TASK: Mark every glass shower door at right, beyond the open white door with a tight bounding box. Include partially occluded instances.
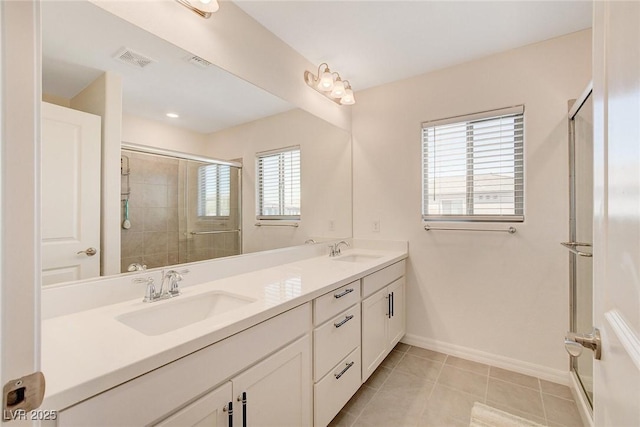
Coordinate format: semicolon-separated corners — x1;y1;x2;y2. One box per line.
570;94;594;407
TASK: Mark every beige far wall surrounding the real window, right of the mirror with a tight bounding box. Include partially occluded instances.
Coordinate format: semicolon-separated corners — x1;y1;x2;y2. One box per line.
353;30;591;380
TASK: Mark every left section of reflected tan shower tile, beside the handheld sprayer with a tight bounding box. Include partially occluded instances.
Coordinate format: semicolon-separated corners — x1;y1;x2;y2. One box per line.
120;150;179;272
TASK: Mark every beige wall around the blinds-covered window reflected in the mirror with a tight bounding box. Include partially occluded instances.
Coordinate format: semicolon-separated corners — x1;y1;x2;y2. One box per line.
208;109;351;252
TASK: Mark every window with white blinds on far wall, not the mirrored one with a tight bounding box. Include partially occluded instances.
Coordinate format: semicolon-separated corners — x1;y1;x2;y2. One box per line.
422;106;524;221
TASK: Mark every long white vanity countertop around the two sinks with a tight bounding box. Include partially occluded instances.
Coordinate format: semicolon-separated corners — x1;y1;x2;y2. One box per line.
42;248;407;410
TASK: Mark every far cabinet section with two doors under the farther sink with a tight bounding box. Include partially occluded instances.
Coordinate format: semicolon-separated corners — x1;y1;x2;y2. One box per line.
362;261;406;382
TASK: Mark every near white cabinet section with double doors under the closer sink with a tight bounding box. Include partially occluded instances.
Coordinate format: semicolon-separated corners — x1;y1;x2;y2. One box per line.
58;303;313;427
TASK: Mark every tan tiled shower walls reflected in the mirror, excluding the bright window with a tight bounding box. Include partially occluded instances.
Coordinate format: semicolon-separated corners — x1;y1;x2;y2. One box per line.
120;150;242;272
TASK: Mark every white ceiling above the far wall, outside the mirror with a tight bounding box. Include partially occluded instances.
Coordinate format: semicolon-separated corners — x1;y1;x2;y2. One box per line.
234;0;592;91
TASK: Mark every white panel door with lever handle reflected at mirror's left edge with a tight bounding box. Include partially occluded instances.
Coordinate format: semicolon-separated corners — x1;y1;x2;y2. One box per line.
42;102;101;285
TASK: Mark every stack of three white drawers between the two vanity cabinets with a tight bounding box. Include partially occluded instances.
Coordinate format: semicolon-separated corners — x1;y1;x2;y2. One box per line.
313;280;362;426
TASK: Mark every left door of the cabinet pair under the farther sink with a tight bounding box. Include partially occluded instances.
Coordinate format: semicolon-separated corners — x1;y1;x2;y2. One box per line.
362;288;389;382
